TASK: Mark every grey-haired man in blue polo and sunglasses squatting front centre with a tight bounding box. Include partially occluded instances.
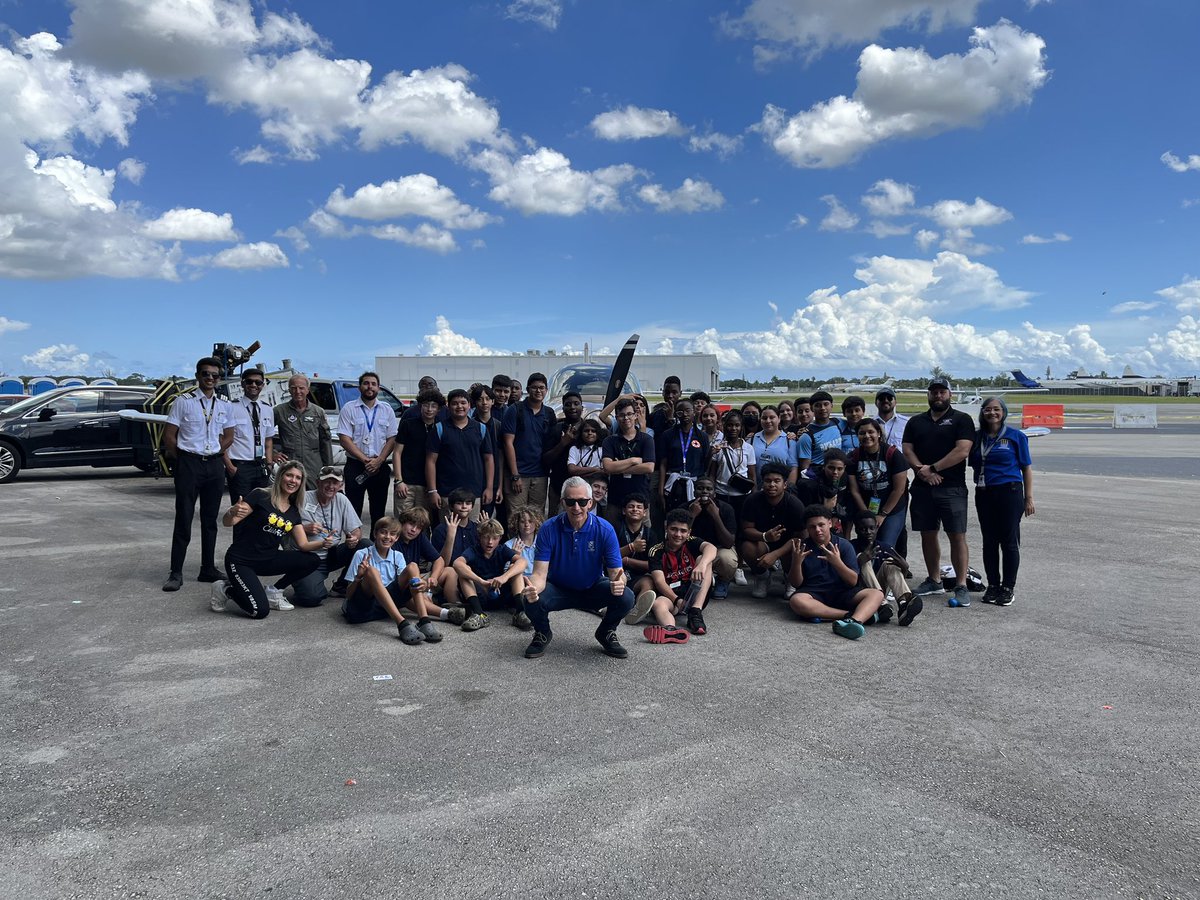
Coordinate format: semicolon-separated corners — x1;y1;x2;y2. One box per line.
524;475;634;659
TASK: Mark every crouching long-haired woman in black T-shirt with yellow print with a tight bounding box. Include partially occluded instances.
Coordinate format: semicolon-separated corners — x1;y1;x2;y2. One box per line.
211;460;335;619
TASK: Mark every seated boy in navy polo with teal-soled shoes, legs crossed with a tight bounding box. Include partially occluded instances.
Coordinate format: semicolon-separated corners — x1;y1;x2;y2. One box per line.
788;504;883;641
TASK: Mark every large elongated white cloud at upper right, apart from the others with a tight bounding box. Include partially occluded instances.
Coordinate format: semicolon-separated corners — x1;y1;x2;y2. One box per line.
756;20;1049;168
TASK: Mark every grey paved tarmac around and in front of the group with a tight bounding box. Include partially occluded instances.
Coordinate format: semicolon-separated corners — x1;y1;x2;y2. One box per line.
0;430;1200;900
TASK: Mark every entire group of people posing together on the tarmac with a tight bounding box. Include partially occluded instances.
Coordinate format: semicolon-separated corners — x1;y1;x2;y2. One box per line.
163;358;1034;658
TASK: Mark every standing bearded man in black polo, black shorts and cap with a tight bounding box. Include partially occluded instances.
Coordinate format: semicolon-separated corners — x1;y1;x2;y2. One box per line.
904;378;974;606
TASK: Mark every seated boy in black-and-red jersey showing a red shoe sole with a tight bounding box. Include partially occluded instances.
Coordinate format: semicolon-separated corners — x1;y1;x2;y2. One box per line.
625;509;716;643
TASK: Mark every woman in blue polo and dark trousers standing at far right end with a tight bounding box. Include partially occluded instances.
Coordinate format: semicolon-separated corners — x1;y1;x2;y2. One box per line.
967;397;1033;606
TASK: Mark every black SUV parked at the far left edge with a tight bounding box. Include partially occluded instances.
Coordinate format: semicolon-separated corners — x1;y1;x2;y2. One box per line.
0;385;154;485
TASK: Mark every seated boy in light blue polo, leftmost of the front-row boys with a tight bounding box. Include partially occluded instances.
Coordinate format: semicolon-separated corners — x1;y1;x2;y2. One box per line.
342;516;442;644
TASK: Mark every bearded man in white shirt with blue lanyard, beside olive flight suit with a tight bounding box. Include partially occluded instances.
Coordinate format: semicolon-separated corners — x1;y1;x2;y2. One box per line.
337;372;398;532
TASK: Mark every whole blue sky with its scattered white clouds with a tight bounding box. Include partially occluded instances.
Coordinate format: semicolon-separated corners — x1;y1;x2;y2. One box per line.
0;0;1200;377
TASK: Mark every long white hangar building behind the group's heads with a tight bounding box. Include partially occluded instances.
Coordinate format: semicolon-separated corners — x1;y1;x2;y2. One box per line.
376;350;721;397
